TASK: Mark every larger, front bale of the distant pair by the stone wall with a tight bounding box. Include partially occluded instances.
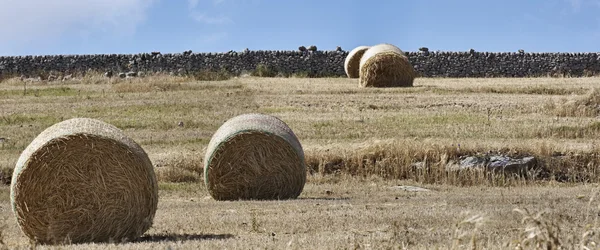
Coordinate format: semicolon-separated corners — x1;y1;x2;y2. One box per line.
359;44;417;87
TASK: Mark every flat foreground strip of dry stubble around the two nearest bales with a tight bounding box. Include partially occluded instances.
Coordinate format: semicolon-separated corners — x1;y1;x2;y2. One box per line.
2;178;600;249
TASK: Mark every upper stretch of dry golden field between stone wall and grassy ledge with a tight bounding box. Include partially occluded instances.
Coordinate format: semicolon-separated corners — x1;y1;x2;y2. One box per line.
0;77;600;182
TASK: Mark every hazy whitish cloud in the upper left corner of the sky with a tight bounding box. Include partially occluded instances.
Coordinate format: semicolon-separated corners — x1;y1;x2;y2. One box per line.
0;0;158;54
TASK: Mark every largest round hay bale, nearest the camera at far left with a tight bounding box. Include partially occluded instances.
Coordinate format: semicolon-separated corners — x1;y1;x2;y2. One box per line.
10;118;158;244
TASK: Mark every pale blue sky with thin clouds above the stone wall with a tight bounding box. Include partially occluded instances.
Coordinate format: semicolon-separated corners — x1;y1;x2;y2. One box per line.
0;0;600;56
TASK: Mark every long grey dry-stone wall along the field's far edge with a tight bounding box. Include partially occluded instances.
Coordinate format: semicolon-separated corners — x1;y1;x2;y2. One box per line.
0;51;600;79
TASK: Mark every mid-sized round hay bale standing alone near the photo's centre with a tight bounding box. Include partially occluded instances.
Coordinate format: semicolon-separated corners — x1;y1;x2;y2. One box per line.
204;114;306;200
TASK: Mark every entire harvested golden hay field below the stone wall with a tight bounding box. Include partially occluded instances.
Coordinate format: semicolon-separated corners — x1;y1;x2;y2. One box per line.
0;77;600;249
